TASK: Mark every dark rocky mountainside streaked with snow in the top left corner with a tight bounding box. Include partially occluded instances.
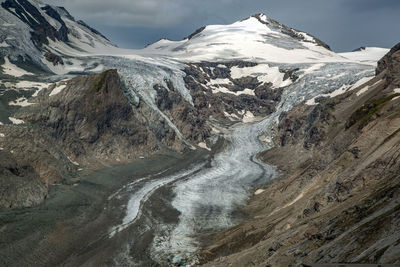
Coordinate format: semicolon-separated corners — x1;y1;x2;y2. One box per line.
0;0;113;73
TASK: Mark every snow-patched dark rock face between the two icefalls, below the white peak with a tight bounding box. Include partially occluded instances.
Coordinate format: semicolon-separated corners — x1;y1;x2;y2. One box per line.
184;61;289;122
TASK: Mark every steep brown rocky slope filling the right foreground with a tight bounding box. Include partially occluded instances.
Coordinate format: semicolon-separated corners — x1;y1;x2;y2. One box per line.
203;45;400;266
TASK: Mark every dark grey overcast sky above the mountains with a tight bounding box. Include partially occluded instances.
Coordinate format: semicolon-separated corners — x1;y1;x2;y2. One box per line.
43;0;400;51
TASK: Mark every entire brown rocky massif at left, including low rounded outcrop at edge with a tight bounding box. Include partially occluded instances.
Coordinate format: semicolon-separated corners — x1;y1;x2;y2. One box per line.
0;70;185;208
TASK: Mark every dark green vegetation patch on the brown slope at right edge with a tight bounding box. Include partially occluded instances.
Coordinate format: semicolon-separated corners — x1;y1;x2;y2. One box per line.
346;93;400;130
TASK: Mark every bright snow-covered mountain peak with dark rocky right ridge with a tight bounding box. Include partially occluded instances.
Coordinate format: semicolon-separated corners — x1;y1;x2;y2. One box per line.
144;14;343;63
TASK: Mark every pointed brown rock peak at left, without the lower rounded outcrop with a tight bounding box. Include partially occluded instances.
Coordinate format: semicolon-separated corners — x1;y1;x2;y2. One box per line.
21;70;161;163
